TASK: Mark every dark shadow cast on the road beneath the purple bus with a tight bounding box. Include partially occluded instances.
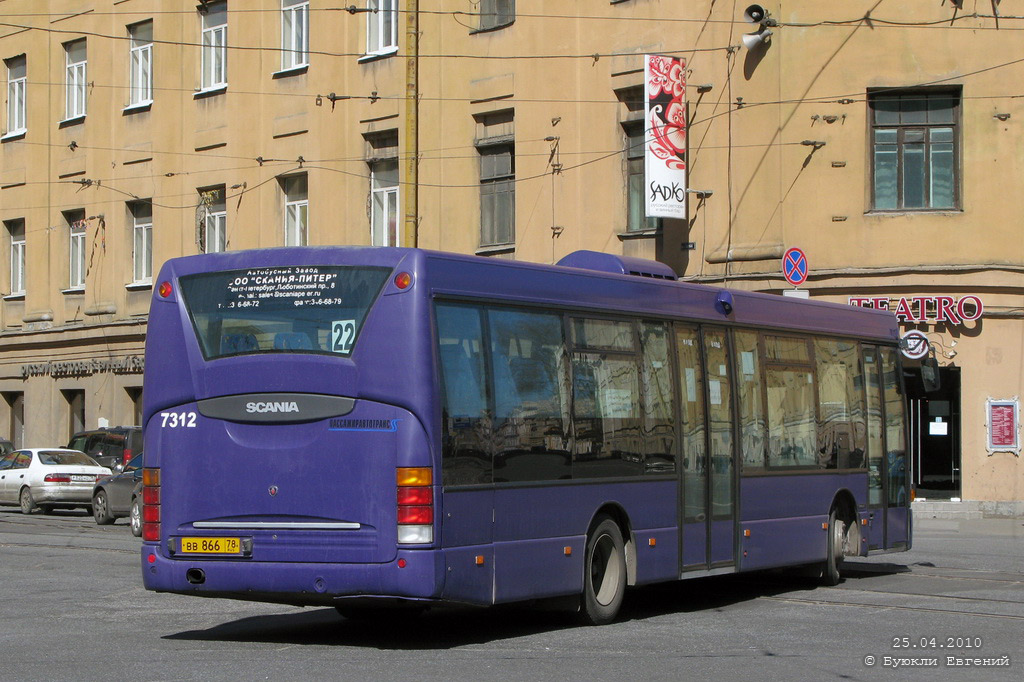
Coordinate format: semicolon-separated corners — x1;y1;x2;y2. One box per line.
164;563;909;650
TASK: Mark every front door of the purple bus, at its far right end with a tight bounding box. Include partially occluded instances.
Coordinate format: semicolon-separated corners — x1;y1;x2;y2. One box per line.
864;345;910;549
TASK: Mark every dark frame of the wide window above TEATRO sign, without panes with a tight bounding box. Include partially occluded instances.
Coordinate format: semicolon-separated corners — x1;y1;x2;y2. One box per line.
867;88;963;213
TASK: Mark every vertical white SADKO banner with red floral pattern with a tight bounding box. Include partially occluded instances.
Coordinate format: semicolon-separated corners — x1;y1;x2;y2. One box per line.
644;54;686;218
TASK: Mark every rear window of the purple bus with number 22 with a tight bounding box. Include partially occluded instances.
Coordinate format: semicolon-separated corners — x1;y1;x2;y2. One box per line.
179;265;390;359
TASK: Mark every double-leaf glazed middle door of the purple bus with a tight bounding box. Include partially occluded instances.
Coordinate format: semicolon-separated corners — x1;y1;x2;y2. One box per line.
676;326;734;570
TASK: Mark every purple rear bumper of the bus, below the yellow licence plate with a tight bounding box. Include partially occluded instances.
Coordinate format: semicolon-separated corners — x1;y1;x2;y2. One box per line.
141;544;444;606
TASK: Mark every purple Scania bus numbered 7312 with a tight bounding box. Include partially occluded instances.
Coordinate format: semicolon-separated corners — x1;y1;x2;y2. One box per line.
141;247;911;624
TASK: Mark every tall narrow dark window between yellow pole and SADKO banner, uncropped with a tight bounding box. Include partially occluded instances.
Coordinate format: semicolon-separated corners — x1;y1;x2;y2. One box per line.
476;112;515;247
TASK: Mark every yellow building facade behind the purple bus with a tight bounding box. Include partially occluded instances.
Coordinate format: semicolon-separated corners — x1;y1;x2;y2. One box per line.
0;0;1024;504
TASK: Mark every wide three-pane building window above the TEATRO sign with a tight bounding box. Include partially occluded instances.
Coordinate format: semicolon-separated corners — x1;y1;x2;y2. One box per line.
868;90;961;211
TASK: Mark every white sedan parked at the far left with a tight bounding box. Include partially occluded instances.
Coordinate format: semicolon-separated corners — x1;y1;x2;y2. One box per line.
0;447;111;514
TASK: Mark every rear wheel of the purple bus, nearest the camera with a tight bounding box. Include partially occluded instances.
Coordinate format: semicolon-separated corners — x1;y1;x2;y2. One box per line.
581;516;626;625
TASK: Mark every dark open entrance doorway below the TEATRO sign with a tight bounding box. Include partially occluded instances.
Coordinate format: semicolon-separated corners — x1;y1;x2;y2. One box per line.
905;367;961;499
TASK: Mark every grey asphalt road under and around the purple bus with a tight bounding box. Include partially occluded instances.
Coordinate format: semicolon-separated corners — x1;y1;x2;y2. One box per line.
0;507;1024;682
